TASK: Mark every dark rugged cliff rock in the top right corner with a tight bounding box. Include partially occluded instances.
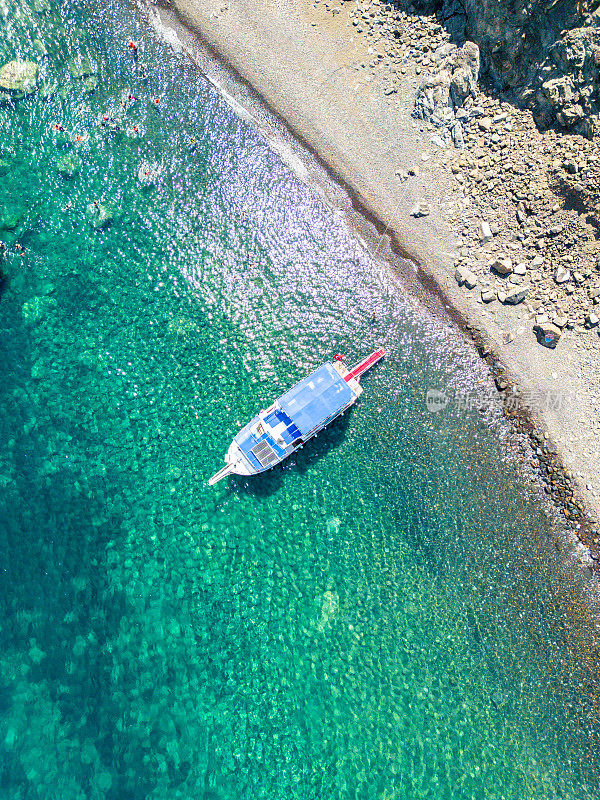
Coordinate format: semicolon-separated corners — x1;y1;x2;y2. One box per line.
413;0;600;137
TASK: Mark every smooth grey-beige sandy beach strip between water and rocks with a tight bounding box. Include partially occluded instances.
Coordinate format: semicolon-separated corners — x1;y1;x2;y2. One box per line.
144;0;600;544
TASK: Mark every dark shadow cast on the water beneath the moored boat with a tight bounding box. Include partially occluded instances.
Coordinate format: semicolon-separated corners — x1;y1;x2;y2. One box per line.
230;408;354;497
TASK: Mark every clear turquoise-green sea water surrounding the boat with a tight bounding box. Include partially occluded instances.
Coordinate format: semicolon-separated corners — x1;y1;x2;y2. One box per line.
0;4;598;800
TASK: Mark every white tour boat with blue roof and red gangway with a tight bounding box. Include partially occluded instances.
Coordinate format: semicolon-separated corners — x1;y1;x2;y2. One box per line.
208;348;385;486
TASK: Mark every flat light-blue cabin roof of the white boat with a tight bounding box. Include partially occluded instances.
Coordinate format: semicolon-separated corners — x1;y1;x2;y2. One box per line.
277;361;354;436
